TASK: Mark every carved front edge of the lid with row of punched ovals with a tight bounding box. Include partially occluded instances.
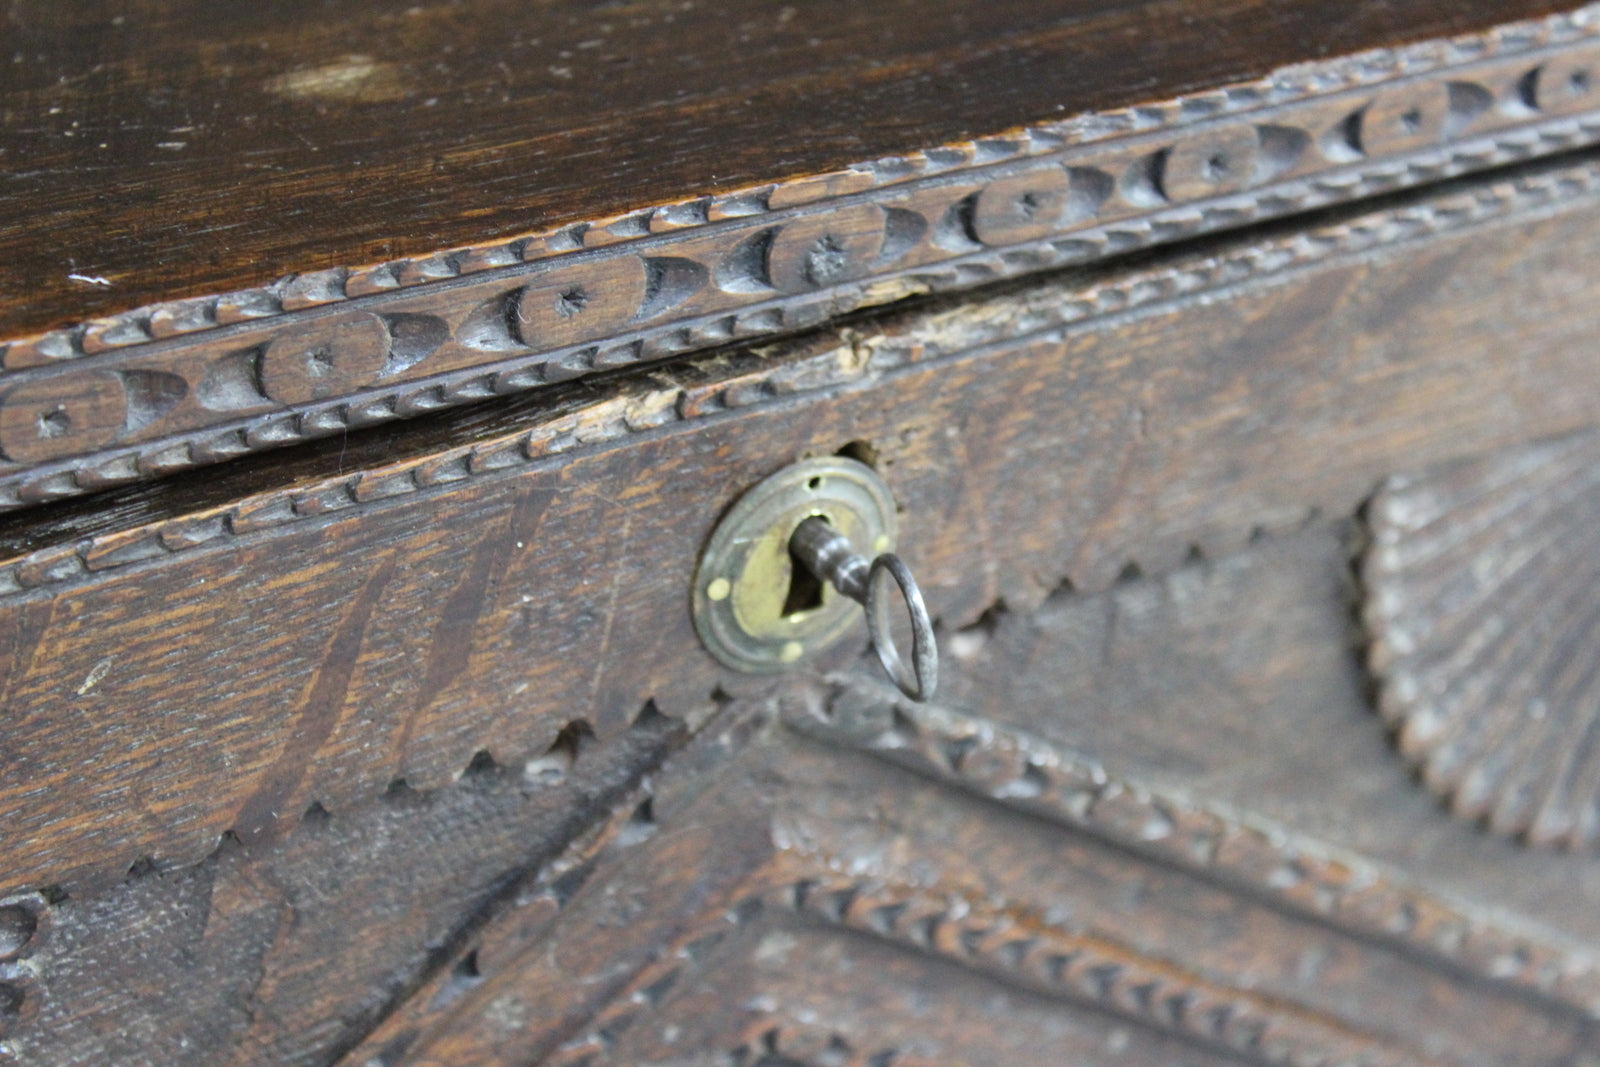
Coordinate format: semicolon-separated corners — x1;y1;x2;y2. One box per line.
9;6;1600;509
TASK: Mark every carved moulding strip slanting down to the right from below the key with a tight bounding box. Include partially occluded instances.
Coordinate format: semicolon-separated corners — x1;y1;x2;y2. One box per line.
786;683;1600;1017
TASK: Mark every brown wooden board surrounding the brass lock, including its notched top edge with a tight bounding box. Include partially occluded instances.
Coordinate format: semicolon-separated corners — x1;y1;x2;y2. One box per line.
0;146;1600;889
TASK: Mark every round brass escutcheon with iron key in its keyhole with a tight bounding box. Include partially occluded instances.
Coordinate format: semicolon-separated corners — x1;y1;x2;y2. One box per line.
693;456;938;699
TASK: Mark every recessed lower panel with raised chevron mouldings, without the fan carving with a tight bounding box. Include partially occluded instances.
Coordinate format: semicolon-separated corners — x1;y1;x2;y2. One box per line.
18;523;1600;1067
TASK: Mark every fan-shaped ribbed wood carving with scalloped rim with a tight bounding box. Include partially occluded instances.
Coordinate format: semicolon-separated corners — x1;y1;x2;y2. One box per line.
1365;434;1600;848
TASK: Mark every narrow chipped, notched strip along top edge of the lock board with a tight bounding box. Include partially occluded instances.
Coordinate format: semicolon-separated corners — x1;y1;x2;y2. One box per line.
0;147;1600;603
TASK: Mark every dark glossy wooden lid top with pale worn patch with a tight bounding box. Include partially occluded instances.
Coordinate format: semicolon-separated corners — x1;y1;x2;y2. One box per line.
0;0;1573;336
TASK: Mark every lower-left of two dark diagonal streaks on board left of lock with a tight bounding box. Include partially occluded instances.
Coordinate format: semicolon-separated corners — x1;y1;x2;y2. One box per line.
234;557;397;845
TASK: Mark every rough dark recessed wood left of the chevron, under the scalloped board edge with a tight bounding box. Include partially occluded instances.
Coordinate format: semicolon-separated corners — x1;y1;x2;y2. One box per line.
0;712;683;1067
